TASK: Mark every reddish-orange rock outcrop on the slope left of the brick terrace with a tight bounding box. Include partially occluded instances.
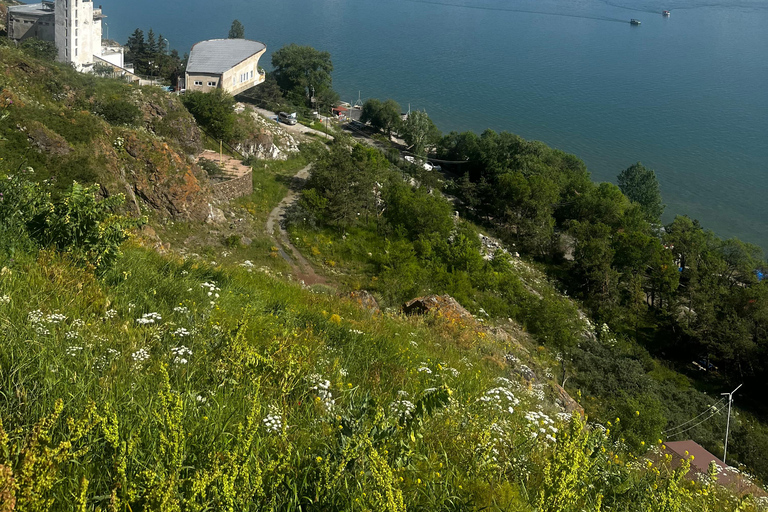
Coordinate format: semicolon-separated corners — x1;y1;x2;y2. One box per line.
123;134;211;220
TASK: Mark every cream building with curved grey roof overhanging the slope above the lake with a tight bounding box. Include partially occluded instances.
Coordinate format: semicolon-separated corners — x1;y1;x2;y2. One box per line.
185;39;267;95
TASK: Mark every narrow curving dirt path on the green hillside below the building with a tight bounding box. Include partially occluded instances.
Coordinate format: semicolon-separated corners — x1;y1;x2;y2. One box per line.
265;164;328;286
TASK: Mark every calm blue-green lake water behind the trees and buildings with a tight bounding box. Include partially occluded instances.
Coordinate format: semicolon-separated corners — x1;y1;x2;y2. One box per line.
99;0;768;248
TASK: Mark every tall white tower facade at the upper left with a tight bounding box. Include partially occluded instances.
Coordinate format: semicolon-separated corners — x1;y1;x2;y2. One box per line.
55;0;103;71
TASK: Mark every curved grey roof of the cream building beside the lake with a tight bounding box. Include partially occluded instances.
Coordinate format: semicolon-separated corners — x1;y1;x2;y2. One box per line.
187;39;267;75
